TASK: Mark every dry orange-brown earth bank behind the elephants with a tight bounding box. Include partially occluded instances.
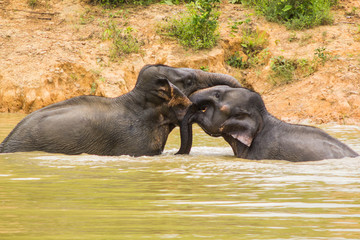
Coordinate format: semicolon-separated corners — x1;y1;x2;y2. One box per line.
0;0;360;124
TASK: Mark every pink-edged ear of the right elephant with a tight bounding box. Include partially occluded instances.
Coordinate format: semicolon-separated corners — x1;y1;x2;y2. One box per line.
220;113;258;147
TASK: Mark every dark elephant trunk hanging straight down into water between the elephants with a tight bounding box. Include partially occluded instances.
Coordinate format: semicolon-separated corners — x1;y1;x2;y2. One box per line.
176;105;197;154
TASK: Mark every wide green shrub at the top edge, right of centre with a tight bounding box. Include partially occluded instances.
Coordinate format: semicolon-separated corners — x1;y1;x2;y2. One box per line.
232;0;337;29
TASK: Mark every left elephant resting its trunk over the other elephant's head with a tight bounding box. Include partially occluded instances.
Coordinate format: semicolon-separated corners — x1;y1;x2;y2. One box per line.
0;65;240;156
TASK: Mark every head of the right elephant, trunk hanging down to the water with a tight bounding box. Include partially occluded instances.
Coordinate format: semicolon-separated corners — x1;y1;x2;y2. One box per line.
179;86;266;156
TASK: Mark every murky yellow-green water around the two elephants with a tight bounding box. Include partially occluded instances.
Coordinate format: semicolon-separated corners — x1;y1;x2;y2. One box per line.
0;114;360;240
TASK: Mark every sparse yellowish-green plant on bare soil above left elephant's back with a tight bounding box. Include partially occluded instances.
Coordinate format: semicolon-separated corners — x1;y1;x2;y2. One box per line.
102;21;142;60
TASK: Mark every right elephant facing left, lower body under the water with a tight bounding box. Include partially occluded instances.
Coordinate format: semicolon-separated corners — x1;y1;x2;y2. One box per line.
182;86;359;162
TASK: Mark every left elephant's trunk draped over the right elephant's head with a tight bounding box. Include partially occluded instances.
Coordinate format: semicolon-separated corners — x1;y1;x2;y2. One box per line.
196;70;241;88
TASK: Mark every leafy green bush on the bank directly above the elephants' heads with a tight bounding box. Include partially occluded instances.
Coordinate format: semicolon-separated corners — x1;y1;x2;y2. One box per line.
158;0;220;50
